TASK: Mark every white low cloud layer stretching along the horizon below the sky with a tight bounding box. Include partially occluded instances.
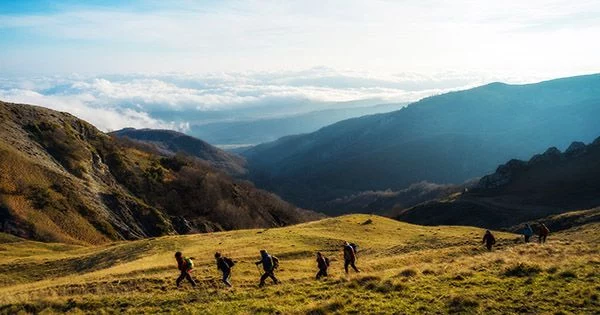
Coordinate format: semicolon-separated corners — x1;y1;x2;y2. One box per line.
0;68;560;131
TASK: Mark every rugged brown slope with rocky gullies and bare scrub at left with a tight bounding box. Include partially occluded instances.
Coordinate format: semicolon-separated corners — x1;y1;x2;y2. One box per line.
0;102;315;244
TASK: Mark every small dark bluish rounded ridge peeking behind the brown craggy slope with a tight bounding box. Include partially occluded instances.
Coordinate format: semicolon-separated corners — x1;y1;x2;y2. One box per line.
111;128;247;176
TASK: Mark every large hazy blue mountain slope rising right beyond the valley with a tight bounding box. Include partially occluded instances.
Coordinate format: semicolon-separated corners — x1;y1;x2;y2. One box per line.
244;75;600;209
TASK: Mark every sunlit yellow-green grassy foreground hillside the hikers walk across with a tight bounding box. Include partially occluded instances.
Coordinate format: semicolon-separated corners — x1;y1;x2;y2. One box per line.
0;215;600;314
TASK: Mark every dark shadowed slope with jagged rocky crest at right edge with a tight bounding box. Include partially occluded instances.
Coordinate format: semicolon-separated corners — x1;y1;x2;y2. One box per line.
396;137;600;228
